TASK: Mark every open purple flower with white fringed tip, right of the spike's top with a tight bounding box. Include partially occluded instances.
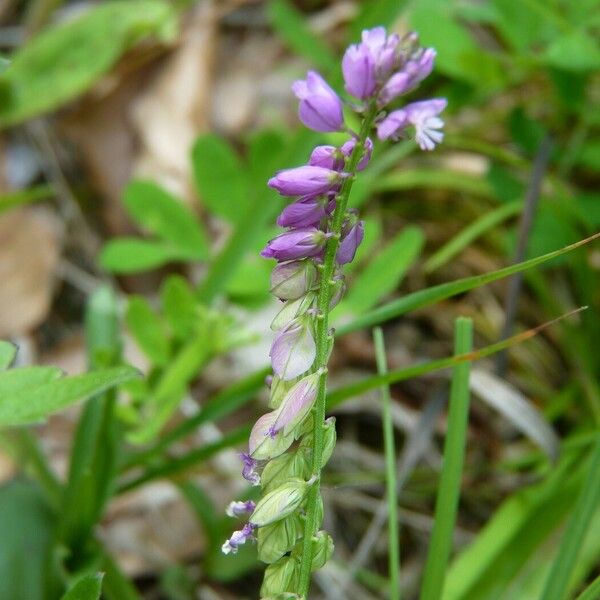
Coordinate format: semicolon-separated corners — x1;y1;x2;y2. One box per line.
377;98;447;150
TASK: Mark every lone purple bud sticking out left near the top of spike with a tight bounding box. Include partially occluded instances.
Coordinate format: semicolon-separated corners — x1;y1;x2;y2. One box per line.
292;71;344;132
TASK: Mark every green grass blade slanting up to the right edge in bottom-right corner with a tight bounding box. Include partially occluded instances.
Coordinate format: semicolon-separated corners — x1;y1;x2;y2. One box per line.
540;435;600;600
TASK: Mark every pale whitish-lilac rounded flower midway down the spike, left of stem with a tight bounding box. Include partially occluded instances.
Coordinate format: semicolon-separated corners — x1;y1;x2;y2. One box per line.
269;317;317;380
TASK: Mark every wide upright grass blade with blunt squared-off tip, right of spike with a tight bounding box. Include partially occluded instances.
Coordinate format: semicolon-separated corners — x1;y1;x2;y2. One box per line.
420;317;473;600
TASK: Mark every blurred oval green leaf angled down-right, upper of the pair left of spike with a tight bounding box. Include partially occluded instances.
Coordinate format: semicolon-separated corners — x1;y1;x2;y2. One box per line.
123;180;208;260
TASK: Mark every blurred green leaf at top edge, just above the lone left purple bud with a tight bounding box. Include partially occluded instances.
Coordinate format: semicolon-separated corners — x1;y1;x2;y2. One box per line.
268;0;338;73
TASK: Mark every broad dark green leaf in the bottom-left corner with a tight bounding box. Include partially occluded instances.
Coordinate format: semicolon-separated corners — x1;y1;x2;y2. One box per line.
0;480;64;600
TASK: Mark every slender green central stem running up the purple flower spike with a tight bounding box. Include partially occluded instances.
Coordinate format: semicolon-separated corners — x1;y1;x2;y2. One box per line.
299;103;377;597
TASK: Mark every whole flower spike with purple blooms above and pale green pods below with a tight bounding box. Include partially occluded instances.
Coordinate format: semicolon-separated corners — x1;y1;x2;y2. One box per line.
223;27;446;598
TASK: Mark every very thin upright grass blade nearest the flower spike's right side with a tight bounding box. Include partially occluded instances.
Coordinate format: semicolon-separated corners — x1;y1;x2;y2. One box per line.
373;327;400;600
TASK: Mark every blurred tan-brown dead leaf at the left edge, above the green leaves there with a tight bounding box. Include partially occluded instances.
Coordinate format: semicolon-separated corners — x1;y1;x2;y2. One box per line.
0;208;61;337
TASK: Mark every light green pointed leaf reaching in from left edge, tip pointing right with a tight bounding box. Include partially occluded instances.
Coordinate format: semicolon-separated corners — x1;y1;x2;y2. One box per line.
0;367;139;426
